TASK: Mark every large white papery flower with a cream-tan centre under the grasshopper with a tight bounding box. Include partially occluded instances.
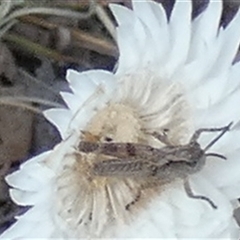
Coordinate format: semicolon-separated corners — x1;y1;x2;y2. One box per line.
1;0;240;239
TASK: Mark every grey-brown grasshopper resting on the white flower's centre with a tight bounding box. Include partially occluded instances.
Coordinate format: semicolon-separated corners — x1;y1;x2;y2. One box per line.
79;122;232;209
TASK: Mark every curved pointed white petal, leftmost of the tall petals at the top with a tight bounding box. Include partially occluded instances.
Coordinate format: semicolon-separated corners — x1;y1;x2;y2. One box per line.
110;4;152;74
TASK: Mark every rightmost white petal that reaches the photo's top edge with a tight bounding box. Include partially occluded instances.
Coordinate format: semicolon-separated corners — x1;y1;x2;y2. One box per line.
175;0;223;86
